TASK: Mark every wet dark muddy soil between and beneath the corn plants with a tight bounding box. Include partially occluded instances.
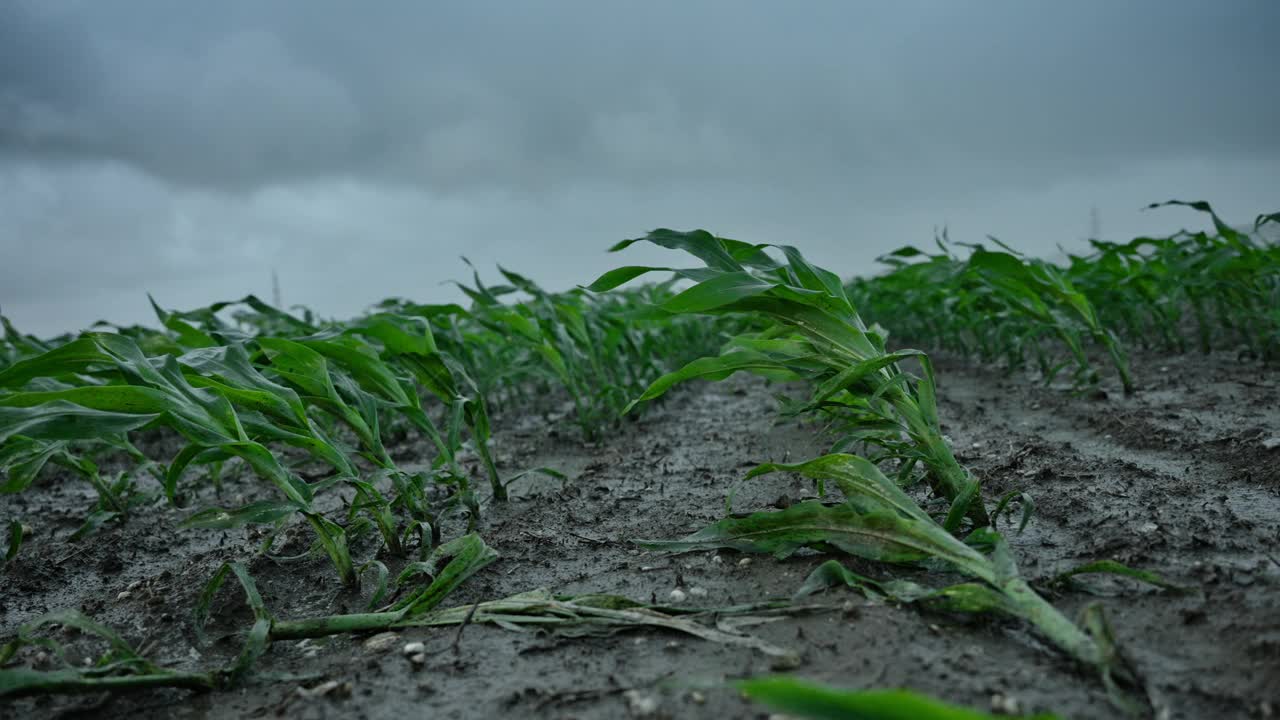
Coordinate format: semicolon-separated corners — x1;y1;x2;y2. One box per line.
0;345;1280;720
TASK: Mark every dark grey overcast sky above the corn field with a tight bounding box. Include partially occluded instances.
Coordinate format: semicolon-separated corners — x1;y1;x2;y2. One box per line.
0;0;1280;334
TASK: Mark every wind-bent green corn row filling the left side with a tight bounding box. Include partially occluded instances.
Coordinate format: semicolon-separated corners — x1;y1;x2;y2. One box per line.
0;270;718;585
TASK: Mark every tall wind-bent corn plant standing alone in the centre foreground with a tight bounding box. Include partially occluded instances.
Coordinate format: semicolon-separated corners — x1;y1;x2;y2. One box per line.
589;229;987;529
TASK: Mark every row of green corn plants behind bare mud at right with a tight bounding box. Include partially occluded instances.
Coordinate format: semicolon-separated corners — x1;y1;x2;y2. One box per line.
847;200;1280;392
